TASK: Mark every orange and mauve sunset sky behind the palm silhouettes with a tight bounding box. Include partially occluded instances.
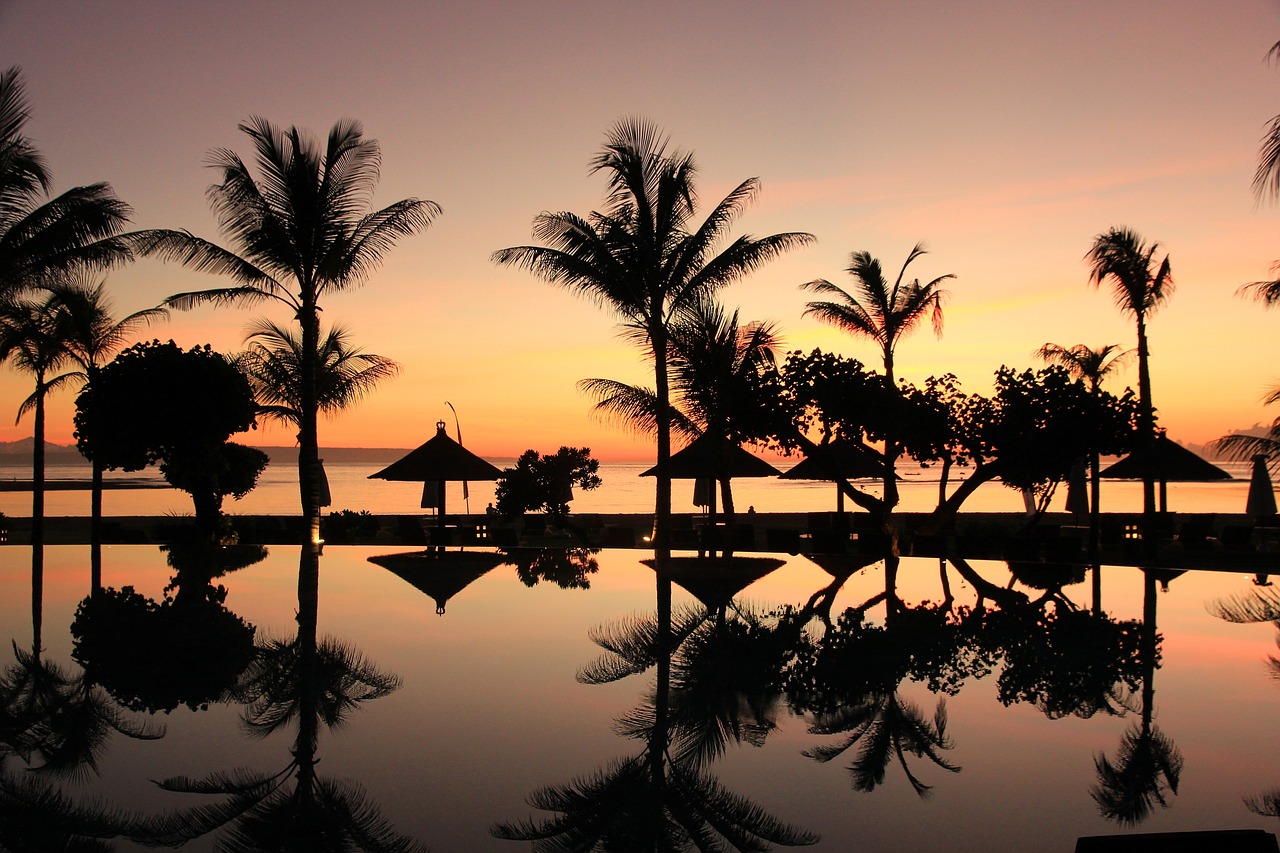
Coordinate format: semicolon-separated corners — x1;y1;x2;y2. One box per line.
0;0;1280;459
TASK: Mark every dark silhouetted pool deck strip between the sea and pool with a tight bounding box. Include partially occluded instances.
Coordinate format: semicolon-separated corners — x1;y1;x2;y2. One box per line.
5;512;1280;574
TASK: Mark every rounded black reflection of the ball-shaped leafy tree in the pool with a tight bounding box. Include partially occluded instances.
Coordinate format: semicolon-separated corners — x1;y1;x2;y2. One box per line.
72;578;255;712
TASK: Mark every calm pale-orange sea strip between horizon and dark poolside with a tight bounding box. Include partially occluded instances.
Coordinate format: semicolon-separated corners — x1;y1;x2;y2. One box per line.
0;456;1249;517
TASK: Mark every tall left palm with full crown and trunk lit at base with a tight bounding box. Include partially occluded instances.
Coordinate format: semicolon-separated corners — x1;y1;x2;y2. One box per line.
134;117;440;542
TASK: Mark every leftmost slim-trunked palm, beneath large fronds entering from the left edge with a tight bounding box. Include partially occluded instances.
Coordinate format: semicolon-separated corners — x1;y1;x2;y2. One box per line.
0;293;77;546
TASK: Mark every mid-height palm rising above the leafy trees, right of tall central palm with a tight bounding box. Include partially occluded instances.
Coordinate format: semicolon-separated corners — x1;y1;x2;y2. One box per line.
800;243;955;515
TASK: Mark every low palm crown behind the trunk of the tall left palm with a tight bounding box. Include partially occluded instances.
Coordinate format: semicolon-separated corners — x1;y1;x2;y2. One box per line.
234;319;399;427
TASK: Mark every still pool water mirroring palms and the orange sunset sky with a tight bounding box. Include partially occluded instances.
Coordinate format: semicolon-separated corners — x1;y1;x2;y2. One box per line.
0;546;1280;850
